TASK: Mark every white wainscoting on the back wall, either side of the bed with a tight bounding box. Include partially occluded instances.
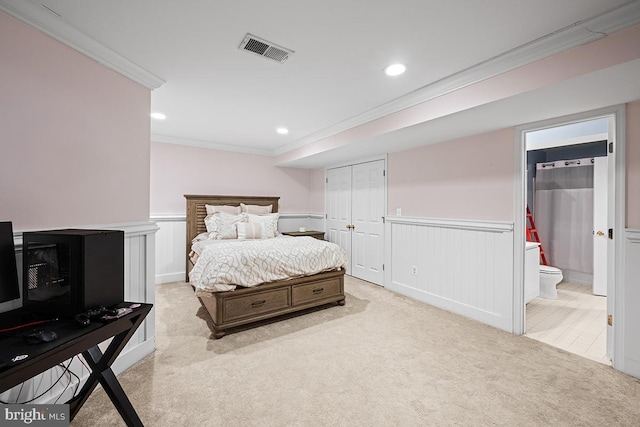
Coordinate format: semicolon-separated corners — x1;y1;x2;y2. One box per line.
151;212;324;284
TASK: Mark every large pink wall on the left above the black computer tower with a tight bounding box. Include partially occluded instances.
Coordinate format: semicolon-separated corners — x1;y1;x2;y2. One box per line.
0;12;150;230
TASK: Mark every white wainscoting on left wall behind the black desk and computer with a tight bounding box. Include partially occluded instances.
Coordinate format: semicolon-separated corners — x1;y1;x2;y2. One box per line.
0;222;158;403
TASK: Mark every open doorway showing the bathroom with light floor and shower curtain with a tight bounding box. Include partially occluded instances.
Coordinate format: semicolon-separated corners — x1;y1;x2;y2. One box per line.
525;123;611;365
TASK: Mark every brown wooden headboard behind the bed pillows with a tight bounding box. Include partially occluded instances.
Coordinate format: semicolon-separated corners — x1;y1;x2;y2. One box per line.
184;194;280;282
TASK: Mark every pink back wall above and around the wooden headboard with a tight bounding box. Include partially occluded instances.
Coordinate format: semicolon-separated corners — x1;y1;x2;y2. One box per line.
151;142;324;215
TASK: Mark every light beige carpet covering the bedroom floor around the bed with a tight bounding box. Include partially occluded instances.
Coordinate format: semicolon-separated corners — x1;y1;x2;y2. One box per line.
72;277;640;427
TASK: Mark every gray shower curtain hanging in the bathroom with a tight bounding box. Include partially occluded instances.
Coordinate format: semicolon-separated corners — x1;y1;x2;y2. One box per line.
534;159;593;285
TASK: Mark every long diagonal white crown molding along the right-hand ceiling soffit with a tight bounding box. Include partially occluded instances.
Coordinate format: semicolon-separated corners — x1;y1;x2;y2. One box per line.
274;0;640;155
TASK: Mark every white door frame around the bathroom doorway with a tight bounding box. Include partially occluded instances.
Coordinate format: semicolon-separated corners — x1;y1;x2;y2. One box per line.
512;104;627;370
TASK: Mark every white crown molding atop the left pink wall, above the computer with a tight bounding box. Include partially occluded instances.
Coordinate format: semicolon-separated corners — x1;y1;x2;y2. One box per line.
0;0;165;90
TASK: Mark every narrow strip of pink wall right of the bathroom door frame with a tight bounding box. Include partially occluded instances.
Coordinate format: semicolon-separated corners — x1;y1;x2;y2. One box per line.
626;101;640;229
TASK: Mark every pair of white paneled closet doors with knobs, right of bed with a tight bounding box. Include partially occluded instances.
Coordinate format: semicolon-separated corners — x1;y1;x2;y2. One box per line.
326;160;385;285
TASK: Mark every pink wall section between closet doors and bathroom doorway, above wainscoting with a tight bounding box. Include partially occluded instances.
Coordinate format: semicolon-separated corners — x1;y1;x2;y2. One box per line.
387;128;515;221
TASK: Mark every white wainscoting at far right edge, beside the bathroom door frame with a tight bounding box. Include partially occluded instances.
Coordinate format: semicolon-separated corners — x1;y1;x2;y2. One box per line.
614;229;640;378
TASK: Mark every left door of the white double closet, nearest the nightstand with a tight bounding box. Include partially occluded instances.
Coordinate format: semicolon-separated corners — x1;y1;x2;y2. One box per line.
326;166;352;274
